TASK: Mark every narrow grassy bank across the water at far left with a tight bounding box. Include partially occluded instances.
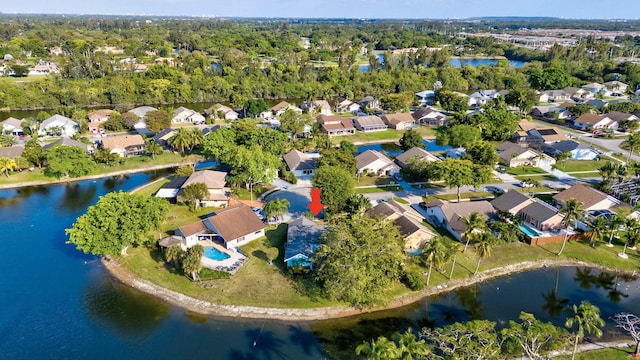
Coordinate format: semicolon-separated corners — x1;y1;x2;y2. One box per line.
0;153;201;185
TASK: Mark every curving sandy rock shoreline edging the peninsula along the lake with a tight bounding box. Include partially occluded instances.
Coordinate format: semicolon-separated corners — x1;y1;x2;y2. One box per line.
101;258;631;321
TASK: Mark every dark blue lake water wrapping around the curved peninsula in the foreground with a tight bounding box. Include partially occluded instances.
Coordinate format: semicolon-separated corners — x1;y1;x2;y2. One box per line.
0;172;640;360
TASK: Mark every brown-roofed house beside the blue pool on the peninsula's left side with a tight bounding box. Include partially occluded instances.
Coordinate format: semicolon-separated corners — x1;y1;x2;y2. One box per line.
205;204;265;249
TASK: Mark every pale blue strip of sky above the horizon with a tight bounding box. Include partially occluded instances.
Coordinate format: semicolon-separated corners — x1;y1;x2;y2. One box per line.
0;0;640;19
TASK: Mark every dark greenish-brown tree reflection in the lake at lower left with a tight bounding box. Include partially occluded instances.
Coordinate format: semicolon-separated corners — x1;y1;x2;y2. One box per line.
85;275;170;336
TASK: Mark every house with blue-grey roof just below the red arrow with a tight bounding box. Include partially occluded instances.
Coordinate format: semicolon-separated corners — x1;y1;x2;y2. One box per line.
284;216;327;268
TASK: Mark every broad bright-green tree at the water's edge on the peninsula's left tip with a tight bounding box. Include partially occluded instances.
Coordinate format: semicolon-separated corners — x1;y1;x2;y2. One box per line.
66;192;169;256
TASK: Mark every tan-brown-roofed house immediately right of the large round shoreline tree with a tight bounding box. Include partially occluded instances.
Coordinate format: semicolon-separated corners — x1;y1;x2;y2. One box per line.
367;201;436;250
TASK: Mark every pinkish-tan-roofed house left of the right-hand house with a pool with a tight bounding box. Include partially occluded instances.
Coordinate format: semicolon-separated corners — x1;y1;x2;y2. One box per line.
425;200;498;240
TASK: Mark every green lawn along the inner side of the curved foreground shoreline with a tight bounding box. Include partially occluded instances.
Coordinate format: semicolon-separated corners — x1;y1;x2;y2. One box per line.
121;181;640;308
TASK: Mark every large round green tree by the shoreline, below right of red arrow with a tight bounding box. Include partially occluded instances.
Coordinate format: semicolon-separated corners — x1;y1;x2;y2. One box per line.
313;215;404;306
